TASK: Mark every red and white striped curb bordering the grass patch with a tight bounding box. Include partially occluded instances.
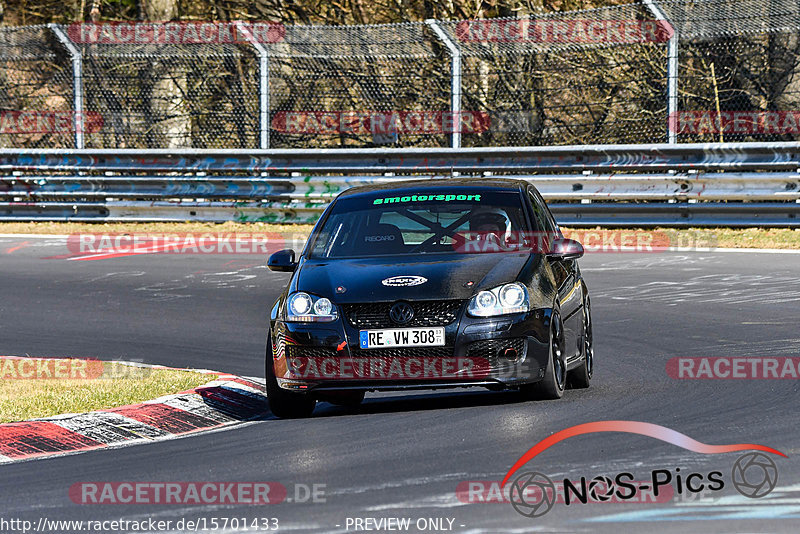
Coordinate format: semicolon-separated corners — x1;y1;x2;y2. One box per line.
0;362;267;464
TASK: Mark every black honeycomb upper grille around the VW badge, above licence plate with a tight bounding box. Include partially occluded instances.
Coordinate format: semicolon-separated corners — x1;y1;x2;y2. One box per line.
342;300;464;328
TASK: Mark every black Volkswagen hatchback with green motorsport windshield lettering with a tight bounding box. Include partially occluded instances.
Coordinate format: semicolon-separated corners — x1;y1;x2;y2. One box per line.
266;179;593;417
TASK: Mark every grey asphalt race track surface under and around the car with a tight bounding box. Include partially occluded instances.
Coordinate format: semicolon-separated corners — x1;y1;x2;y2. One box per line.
0;237;800;532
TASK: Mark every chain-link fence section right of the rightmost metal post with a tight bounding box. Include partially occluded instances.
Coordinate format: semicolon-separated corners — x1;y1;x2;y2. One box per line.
659;0;800;142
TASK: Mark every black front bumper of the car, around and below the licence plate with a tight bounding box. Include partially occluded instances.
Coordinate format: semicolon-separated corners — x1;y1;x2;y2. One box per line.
271;309;552;392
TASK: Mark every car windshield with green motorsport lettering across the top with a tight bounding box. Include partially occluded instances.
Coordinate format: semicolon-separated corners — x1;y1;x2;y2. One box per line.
310;188;530;258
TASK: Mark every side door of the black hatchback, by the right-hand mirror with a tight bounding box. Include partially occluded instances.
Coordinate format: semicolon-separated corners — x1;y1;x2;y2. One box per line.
528;186;583;361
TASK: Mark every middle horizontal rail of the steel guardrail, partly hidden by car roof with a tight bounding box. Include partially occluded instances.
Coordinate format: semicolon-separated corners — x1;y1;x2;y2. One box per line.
0;172;800;201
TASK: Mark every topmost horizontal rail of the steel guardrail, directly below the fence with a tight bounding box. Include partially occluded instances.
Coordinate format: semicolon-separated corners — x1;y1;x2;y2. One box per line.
0;142;800;173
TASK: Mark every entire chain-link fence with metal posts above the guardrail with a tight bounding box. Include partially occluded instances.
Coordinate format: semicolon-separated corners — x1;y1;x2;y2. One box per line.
0;0;800;148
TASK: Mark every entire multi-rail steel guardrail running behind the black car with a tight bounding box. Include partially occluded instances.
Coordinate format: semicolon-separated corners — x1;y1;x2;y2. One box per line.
0;143;800;226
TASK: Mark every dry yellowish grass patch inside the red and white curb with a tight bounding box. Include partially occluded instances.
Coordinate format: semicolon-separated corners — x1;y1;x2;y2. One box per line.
0;358;217;423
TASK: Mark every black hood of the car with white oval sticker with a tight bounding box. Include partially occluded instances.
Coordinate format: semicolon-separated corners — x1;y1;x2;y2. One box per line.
292;253;530;303
